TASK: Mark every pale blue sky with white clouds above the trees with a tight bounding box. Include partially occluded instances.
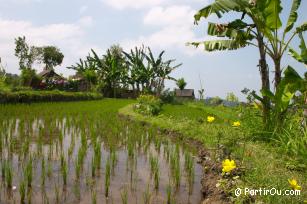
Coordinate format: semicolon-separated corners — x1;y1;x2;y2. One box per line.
0;0;307;100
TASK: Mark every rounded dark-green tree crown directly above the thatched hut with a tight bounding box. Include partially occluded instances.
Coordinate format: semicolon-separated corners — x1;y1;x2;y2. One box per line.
38;46;64;70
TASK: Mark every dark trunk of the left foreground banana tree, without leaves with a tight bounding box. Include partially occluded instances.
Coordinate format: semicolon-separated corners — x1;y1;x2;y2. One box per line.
257;34;271;130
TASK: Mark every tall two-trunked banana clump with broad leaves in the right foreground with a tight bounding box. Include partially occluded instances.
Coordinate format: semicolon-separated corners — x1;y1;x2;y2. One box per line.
192;0;307;129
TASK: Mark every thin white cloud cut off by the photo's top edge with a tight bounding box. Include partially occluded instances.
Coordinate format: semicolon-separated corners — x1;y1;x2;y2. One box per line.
101;0;167;10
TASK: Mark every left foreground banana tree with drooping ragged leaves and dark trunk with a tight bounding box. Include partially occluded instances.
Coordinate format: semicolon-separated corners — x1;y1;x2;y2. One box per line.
191;0;270;126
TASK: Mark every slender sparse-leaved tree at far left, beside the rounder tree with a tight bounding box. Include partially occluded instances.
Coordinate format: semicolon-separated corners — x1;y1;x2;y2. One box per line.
15;36;37;70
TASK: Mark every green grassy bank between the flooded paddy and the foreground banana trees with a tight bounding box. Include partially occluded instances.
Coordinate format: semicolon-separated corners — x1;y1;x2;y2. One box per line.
119;103;307;203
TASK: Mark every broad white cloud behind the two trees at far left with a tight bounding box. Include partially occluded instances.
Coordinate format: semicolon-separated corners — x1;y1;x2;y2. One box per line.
0;18;101;75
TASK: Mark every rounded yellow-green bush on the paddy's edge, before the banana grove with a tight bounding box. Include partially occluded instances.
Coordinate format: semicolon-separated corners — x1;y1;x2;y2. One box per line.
134;95;162;115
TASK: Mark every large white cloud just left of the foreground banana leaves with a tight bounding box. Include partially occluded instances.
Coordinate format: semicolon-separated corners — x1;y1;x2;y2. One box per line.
121;5;206;55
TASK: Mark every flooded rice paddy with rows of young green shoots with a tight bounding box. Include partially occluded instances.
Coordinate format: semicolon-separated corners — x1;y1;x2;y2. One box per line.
0;99;202;204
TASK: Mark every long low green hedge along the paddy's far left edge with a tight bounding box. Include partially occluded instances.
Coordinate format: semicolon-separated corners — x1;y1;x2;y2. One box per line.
0;91;102;103
